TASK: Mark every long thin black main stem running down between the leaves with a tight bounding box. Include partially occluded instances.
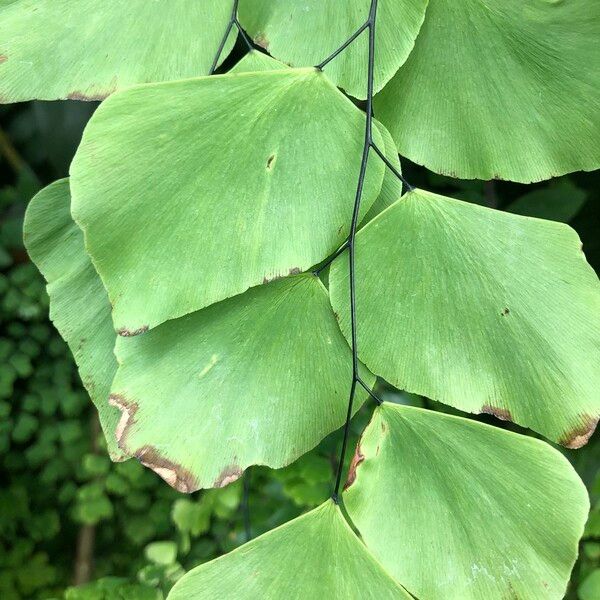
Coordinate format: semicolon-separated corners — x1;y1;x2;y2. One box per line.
330;0;377;504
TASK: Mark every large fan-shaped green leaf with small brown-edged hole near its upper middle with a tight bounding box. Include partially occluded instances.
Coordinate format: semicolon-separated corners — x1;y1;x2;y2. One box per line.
71;69;383;335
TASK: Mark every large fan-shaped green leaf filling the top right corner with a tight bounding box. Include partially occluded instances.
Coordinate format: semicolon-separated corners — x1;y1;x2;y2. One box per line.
375;0;600;182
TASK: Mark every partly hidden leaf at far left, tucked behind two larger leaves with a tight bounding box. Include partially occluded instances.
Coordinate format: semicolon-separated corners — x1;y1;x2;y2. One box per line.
23;179;124;460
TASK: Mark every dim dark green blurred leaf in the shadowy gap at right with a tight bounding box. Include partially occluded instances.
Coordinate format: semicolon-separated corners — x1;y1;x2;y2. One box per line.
506;179;587;223
